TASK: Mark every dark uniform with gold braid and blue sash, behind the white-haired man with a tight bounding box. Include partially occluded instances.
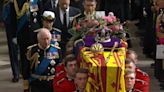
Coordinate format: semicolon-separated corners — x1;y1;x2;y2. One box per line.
14;0;41;84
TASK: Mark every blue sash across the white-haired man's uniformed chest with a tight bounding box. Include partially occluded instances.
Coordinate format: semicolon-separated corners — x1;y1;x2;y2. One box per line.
29;47;57;83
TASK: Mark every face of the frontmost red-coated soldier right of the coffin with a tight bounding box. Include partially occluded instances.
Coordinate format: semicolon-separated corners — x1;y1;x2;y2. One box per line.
125;73;135;91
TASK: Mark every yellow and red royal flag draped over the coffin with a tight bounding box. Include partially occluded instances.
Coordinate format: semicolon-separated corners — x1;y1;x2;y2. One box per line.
80;47;126;92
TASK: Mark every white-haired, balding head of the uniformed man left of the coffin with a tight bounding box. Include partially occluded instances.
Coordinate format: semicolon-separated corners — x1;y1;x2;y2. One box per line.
37;28;52;48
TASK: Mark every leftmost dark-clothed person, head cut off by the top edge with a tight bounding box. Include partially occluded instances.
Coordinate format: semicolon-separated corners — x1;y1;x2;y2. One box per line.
2;1;20;82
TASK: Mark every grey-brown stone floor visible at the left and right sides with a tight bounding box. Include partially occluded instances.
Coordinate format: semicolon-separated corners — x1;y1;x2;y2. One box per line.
0;21;164;92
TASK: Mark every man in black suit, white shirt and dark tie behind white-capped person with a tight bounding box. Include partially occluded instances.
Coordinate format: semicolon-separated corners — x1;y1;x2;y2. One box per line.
54;0;80;56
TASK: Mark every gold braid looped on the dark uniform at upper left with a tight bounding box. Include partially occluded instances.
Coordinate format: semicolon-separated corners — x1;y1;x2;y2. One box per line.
14;0;29;19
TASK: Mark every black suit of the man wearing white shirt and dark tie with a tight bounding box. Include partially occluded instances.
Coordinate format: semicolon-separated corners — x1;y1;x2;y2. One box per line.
54;6;80;56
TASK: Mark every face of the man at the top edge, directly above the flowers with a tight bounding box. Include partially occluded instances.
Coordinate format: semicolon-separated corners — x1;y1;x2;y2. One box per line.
84;1;96;13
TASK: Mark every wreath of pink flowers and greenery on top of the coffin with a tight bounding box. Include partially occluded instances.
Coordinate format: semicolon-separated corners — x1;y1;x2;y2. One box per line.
69;12;128;40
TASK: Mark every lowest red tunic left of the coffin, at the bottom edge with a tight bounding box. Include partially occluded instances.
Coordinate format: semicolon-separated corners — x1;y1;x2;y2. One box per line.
53;77;76;92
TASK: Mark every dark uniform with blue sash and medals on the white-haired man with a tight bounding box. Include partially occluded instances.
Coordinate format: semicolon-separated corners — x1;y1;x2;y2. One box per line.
26;44;59;92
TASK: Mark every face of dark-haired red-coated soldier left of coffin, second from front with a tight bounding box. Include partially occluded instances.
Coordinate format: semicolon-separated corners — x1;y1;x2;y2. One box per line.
66;60;77;77
